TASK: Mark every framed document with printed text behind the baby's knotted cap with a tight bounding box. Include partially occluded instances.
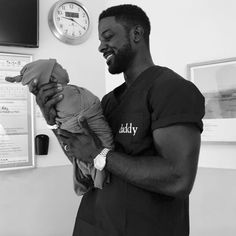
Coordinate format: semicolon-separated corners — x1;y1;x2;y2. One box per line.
0;53;35;171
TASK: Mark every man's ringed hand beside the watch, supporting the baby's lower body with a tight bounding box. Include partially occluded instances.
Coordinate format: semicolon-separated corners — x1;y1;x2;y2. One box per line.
57;118;103;163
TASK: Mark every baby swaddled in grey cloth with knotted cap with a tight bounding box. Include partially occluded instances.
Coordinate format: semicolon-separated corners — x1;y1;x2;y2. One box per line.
6;59;113;195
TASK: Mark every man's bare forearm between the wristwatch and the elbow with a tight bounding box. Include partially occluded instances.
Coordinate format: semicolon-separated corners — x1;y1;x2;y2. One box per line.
106;151;184;196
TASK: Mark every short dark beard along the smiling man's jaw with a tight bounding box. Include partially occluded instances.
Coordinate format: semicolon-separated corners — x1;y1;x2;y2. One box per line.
108;42;134;74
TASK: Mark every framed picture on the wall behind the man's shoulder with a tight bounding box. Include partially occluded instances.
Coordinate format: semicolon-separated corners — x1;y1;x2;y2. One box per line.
187;58;236;142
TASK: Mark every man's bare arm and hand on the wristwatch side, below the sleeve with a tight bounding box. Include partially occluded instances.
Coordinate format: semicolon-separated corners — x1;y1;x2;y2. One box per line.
58;123;200;197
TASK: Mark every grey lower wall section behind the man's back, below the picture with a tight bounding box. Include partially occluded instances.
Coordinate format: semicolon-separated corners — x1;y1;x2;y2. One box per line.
190;168;236;236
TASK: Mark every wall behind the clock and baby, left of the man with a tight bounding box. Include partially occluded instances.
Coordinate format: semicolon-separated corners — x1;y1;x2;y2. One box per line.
0;0;105;236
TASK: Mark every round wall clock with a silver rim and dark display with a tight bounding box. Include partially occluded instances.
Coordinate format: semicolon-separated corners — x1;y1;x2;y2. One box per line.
48;0;91;45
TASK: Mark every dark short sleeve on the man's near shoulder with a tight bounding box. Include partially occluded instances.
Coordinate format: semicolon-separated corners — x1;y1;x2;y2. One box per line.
149;72;205;132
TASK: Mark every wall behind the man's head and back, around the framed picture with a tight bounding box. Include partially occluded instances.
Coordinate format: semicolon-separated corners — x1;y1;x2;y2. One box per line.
106;0;236;236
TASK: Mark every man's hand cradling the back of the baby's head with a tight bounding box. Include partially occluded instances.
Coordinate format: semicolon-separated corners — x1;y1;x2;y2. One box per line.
29;79;63;125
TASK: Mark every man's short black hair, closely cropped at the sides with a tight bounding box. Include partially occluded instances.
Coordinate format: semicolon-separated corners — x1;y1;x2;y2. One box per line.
99;4;151;45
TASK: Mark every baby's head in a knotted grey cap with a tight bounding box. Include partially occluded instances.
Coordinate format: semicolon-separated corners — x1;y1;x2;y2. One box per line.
6;59;69;86
